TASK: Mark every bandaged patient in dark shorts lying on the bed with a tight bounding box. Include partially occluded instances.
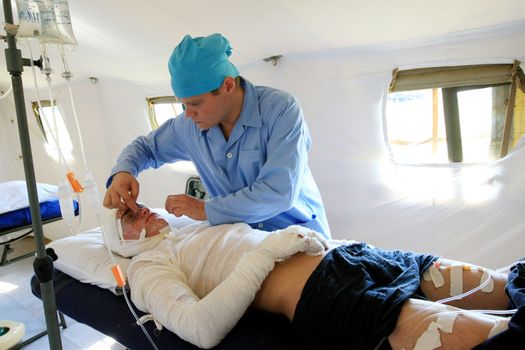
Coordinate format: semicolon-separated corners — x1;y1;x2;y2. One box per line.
104;207;525;350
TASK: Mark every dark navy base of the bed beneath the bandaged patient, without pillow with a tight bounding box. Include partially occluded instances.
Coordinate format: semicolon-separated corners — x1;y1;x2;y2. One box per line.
31;269;295;350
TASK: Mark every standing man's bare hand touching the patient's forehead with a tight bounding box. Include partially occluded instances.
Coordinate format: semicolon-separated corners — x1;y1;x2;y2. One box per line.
103;172;140;217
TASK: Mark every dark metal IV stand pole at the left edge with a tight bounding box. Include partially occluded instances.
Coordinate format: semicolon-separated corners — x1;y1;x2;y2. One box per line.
3;0;62;350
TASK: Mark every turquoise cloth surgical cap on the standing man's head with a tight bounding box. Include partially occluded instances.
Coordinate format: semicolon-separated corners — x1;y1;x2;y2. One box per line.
168;34;239;98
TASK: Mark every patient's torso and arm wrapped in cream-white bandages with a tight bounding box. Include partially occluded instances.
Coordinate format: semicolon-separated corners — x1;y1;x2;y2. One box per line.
128;224;326;348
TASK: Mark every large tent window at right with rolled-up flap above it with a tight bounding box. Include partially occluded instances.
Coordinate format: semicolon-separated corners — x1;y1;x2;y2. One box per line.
386;61;525;164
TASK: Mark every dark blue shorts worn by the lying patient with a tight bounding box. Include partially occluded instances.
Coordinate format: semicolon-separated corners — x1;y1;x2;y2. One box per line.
292;243;438;350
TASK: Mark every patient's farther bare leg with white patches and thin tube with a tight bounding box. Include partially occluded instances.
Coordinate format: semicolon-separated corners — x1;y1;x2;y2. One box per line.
421;259;509;310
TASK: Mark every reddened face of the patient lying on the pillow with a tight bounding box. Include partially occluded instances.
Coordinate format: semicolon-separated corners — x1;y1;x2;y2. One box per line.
121;204;169;240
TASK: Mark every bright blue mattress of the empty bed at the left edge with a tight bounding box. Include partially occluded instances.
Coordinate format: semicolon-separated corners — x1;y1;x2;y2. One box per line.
0;199;79;234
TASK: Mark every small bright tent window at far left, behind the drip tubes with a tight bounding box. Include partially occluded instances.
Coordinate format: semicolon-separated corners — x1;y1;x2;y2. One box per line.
31;100;73;161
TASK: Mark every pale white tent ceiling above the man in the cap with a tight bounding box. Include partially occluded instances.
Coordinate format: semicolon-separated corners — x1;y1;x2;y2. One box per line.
0;0;525;86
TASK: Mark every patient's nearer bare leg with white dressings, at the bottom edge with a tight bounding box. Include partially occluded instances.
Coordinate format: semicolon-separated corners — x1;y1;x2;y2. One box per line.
388;299;508;350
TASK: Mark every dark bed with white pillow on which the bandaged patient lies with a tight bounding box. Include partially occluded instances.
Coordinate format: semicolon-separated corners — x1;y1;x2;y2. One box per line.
31;213;294;350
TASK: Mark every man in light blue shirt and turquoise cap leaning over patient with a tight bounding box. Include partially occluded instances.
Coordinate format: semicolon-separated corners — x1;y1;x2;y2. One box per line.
104;34;330;238
